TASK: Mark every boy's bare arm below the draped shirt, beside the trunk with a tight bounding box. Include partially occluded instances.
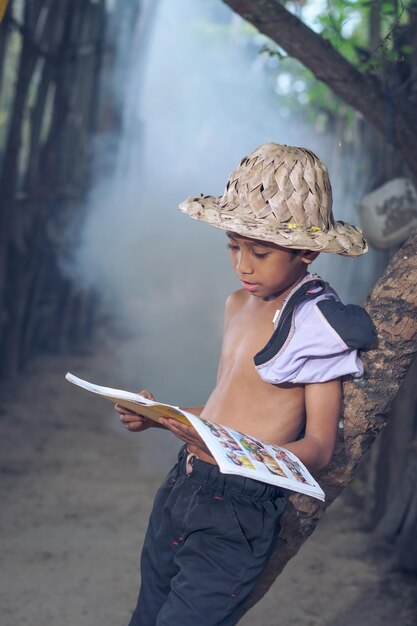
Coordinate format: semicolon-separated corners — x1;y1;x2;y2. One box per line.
283;378;342;473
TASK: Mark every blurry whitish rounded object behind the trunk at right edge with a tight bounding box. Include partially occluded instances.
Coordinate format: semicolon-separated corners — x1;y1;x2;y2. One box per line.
357;178;417;250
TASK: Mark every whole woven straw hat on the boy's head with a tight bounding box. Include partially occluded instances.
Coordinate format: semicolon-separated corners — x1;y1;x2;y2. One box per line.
180;143;368;256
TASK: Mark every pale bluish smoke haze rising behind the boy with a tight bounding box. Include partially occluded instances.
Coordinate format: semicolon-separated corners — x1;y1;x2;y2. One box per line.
70;0;377;405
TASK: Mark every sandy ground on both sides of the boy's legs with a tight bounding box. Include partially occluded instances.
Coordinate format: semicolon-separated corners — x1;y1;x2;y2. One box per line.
0;348;417;626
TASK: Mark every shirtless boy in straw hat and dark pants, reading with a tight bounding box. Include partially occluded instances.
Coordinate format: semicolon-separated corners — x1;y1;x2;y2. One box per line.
116;144;373;626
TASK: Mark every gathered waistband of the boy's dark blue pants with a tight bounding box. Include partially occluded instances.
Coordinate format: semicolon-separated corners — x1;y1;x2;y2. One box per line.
174;446;286;500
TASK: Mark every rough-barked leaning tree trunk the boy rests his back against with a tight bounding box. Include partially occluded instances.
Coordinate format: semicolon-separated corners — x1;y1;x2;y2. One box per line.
245;232;417;606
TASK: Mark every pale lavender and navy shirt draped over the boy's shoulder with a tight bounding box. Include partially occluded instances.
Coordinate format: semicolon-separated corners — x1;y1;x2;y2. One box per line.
254;275;375;384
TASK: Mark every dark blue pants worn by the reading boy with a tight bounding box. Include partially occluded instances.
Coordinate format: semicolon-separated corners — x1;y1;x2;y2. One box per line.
129;448;286;626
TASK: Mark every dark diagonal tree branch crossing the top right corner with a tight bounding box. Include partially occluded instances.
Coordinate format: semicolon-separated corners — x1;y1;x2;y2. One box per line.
224;0;417;187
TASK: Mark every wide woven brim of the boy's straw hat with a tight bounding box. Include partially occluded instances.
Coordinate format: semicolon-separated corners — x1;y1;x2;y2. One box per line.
179;196;368;257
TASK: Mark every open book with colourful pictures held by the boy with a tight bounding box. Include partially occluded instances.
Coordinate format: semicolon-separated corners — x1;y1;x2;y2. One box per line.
65;372;325;501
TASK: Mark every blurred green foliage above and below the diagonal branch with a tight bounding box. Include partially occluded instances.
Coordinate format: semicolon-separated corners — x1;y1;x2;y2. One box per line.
234;0;417;132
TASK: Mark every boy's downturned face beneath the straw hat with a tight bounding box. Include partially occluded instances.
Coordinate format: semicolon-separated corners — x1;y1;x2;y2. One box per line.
226;232;317;299
